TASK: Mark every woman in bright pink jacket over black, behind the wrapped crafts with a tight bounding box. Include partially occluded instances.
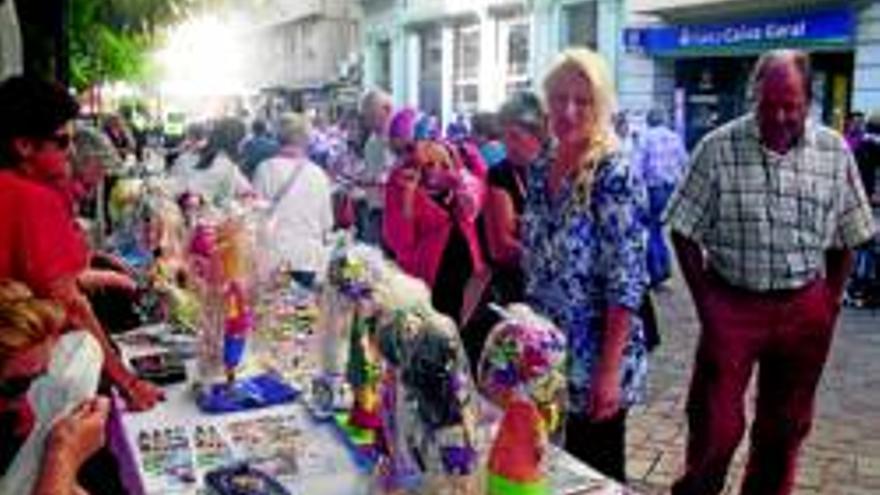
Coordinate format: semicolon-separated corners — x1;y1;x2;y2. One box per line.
383;141;486;321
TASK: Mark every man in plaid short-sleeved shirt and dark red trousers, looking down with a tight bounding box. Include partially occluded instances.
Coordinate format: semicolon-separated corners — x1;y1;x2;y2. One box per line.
665;50;875;495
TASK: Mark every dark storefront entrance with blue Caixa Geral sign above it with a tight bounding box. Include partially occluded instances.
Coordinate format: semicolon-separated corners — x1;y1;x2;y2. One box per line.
624;4;857;147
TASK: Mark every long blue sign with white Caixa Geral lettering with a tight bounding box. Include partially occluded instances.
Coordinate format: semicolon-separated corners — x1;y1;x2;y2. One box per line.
624;9;855;56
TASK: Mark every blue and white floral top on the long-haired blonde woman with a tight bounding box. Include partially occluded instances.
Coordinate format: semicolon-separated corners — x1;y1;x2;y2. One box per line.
522;150;648;414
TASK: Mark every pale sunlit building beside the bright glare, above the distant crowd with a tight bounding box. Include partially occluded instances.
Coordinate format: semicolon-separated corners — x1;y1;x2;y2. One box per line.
240;0;361;114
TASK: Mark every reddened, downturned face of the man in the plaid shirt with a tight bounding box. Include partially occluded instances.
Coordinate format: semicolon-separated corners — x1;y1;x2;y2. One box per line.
757;64;808;153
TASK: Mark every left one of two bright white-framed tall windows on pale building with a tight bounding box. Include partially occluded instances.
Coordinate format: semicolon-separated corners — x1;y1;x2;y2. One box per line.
452;24;480;113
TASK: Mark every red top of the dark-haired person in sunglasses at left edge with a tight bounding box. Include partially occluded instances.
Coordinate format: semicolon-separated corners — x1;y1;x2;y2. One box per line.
0;170;89;296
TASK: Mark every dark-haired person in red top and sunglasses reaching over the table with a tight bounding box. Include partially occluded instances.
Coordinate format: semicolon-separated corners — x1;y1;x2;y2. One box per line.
0;77;162;410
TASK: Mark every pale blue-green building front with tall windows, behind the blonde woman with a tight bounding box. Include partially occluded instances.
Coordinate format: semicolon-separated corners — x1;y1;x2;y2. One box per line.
361;0;625;126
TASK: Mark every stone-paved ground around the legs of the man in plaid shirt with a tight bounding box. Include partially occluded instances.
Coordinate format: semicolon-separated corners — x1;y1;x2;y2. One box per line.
627;276;880;495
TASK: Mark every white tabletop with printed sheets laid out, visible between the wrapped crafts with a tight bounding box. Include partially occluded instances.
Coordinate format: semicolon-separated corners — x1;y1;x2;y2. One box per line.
111;328;628;495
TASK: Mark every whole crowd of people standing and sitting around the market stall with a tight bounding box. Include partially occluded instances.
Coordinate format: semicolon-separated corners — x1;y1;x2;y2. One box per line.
0;44;880;495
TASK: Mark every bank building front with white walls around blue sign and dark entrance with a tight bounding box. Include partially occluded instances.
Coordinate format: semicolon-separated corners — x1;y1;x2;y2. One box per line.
620;0;880;146
